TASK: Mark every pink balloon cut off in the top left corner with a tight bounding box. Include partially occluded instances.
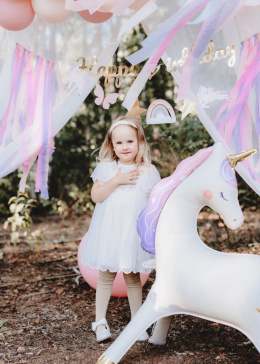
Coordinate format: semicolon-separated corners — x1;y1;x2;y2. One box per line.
0;0;35;31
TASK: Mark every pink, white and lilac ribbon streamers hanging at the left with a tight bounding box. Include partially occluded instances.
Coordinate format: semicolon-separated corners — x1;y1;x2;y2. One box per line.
0;44;60;199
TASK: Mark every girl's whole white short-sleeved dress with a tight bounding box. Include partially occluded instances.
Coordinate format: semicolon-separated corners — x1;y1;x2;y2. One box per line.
81;161;160;273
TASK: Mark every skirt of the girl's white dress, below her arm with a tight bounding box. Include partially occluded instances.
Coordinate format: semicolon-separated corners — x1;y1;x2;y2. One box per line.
81;186;153;273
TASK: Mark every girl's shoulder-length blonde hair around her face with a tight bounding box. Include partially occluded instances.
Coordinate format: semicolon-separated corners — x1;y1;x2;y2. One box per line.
98;116;151;167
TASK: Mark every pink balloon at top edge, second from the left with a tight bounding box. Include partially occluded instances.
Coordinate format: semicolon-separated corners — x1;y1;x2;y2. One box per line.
32;0;72;24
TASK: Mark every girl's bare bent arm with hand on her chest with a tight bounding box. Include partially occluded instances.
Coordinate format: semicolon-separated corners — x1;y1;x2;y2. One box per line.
91;168;139;203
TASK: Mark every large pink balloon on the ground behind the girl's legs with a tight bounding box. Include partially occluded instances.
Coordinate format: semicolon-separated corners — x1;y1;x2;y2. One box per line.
78;235;149;297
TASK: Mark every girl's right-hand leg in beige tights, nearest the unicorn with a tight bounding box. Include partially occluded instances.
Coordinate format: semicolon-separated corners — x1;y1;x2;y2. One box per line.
124;272;142;318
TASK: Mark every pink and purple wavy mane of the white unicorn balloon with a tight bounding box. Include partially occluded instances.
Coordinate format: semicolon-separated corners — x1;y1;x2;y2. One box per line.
137;147;213;254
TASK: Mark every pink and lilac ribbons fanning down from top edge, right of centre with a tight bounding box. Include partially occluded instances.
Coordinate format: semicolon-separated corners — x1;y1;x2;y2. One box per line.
127;0;247;99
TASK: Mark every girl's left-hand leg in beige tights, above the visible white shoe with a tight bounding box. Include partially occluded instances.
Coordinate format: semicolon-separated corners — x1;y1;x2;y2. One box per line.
96;270;116;334
